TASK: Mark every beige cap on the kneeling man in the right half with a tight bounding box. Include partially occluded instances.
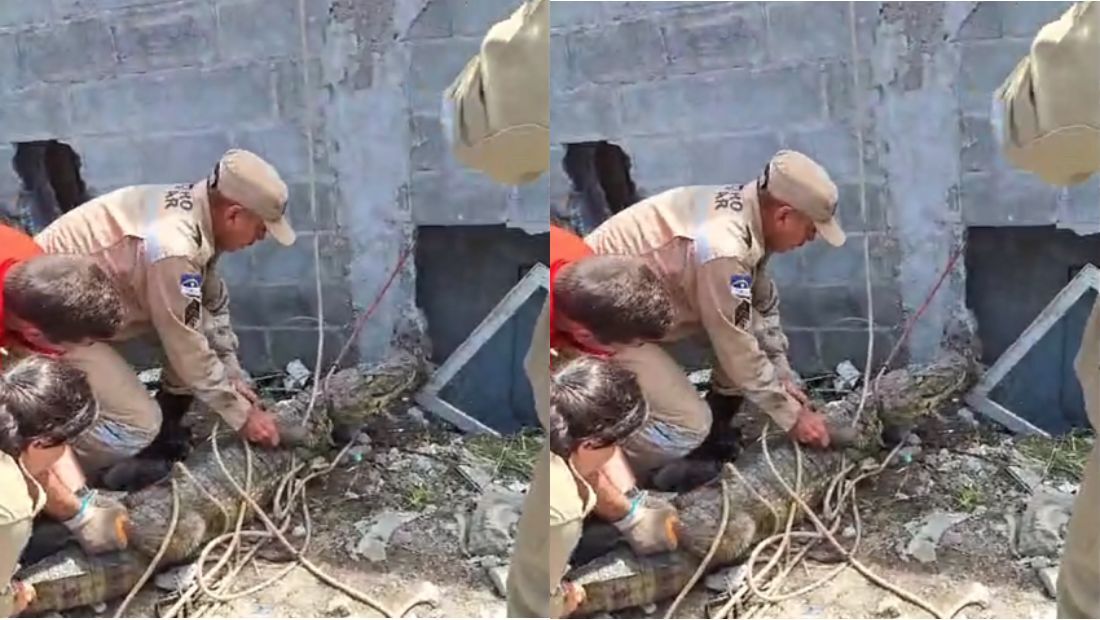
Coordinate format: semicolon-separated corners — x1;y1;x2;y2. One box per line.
760;151;847;247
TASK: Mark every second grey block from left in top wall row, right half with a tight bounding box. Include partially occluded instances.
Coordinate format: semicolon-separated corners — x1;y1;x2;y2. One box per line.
661;3;767;73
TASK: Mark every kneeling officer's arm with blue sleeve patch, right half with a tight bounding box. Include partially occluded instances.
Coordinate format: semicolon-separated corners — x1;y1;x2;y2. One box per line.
696;258;800;431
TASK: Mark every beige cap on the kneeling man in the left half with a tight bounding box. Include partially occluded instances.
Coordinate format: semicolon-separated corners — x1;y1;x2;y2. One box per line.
210;148;297;245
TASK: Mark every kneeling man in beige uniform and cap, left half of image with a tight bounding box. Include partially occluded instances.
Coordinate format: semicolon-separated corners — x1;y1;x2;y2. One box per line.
35;150;295;474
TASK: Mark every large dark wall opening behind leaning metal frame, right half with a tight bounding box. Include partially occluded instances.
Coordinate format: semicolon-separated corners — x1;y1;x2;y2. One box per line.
966;226;1100;433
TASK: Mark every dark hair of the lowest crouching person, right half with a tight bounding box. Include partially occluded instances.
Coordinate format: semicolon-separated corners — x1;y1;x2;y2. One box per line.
548;356;648;457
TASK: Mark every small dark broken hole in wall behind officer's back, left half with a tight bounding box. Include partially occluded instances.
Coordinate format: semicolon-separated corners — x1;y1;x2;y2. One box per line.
12;140;89;232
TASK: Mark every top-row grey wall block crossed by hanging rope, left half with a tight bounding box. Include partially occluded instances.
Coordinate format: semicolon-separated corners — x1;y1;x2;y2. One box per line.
218;0;327;59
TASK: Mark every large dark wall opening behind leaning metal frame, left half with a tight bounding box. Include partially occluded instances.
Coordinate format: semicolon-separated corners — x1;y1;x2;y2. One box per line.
416;226;550;432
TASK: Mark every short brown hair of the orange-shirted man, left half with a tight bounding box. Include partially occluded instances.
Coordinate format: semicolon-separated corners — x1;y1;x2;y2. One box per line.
3;254;122;344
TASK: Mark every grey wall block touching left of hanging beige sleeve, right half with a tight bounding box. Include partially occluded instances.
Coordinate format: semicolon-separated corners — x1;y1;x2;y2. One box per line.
957;40;1031;114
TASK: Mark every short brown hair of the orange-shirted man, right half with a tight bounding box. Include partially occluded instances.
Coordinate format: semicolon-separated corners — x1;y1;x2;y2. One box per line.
553;256;672;344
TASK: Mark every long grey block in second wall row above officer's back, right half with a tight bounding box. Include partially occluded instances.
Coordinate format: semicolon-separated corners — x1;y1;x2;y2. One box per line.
622;66;824;134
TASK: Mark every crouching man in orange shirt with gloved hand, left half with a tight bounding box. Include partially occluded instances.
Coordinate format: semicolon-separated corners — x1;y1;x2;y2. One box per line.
0;226;127;553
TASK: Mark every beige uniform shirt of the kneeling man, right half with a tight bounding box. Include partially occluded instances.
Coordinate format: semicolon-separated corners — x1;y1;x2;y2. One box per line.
584;184;799;430
